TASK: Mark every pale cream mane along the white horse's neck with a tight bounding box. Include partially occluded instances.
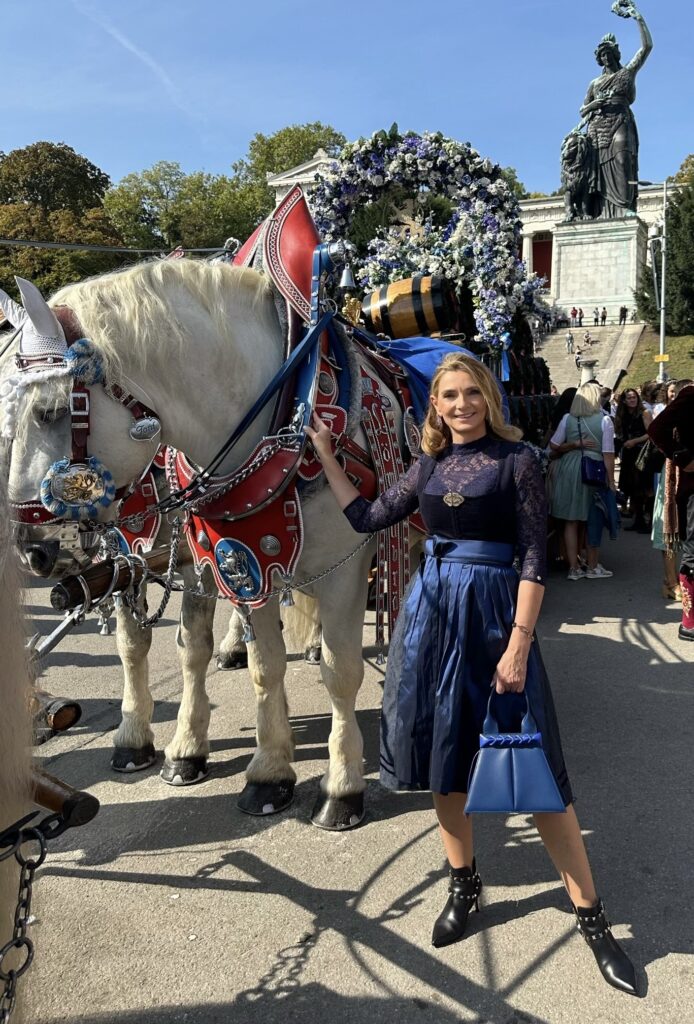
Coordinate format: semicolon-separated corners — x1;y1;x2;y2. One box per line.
50;259;274;380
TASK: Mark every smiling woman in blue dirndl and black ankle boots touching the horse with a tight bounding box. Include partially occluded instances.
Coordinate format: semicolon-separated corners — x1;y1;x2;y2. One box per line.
307;354;636;994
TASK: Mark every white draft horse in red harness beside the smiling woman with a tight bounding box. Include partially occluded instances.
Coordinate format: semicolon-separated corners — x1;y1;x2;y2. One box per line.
6;260;397;828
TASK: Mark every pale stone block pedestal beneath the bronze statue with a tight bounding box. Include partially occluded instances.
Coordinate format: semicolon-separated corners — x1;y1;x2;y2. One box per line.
552;217;648;326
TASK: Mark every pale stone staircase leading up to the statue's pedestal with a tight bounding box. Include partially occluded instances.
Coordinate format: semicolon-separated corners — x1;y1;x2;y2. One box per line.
535;321;645;394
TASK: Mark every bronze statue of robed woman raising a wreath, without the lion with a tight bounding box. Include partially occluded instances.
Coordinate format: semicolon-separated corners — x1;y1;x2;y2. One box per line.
580;0;653;218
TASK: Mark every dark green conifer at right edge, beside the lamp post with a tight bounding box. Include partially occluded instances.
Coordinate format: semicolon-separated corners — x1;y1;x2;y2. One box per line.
635;180;694;335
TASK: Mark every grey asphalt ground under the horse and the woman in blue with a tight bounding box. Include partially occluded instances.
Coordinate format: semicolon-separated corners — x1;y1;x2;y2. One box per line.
25;534;694;1024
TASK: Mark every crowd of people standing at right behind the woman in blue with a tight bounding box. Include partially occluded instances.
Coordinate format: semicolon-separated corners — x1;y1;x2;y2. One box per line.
546;379;694;639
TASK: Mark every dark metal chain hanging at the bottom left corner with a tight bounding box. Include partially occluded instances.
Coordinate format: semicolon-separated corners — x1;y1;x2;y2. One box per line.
0;827;46;1024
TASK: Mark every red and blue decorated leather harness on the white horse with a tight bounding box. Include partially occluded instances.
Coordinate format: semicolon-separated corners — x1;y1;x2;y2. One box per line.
4;188;423;642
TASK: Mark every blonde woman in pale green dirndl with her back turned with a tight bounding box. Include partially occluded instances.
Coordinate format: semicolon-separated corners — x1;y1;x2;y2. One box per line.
550;383;616;581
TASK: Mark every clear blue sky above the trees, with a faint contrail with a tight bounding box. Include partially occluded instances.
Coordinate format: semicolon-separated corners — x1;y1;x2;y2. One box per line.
0;0;694;190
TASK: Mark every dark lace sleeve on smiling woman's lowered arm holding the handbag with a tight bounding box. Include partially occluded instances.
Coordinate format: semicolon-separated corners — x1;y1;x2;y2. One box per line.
514;447;547;586
